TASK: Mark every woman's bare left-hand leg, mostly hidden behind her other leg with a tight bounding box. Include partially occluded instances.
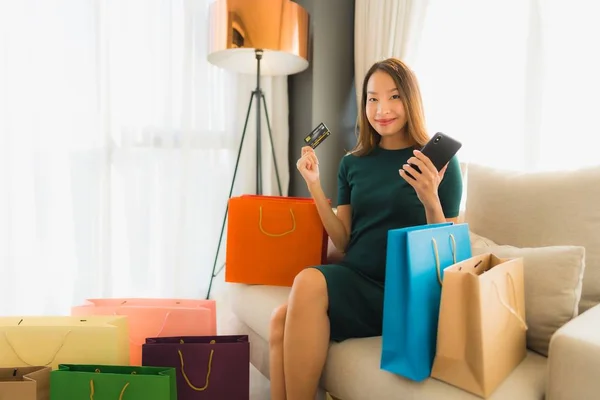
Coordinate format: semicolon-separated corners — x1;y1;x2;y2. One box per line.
269;304;287;400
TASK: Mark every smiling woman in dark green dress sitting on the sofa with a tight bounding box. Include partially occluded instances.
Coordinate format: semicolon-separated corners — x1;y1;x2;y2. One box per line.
269;59;462;400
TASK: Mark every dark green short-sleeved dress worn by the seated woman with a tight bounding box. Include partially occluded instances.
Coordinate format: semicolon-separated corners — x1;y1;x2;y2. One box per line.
315;147;463;342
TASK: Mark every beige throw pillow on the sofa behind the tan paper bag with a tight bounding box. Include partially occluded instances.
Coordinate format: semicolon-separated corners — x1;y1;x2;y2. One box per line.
471;234;585;356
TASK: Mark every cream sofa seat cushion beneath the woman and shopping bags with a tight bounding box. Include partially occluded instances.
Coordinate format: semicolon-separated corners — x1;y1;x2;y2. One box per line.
228;284;546;400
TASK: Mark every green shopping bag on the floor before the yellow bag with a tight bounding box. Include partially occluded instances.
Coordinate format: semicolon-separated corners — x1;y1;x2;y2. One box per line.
50;364;177;400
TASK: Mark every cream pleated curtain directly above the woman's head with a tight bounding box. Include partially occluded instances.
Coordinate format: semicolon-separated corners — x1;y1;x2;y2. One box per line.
354;0;430;104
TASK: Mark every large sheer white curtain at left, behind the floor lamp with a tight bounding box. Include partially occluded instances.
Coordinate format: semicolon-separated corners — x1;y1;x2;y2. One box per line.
0;0;289;315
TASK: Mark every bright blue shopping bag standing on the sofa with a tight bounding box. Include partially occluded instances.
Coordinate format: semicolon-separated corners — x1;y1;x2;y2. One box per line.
381;223;471;381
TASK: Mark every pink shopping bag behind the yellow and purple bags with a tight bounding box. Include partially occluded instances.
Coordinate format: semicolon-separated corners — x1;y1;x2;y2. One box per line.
71;298;217;365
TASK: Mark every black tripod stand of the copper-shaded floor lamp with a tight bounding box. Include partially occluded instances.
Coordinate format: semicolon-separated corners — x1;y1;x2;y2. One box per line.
206;49;283;300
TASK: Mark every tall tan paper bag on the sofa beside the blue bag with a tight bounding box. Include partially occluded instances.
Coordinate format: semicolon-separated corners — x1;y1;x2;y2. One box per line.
431;253;527;397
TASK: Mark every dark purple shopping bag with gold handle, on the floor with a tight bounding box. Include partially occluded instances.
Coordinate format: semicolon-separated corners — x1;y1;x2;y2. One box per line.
142;335;250;400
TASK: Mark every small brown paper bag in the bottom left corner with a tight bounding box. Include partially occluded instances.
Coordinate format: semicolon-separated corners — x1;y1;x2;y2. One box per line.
0;367;52;400
